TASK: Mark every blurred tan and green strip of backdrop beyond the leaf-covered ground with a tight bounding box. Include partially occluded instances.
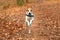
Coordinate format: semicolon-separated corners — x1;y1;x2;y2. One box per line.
0;0;59;10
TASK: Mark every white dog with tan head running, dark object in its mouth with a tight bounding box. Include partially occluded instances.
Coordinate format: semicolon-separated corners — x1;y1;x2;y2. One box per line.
25;8;34;33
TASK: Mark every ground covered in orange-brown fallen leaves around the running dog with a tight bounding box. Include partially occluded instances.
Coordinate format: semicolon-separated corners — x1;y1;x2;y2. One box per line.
0;0;60;40
